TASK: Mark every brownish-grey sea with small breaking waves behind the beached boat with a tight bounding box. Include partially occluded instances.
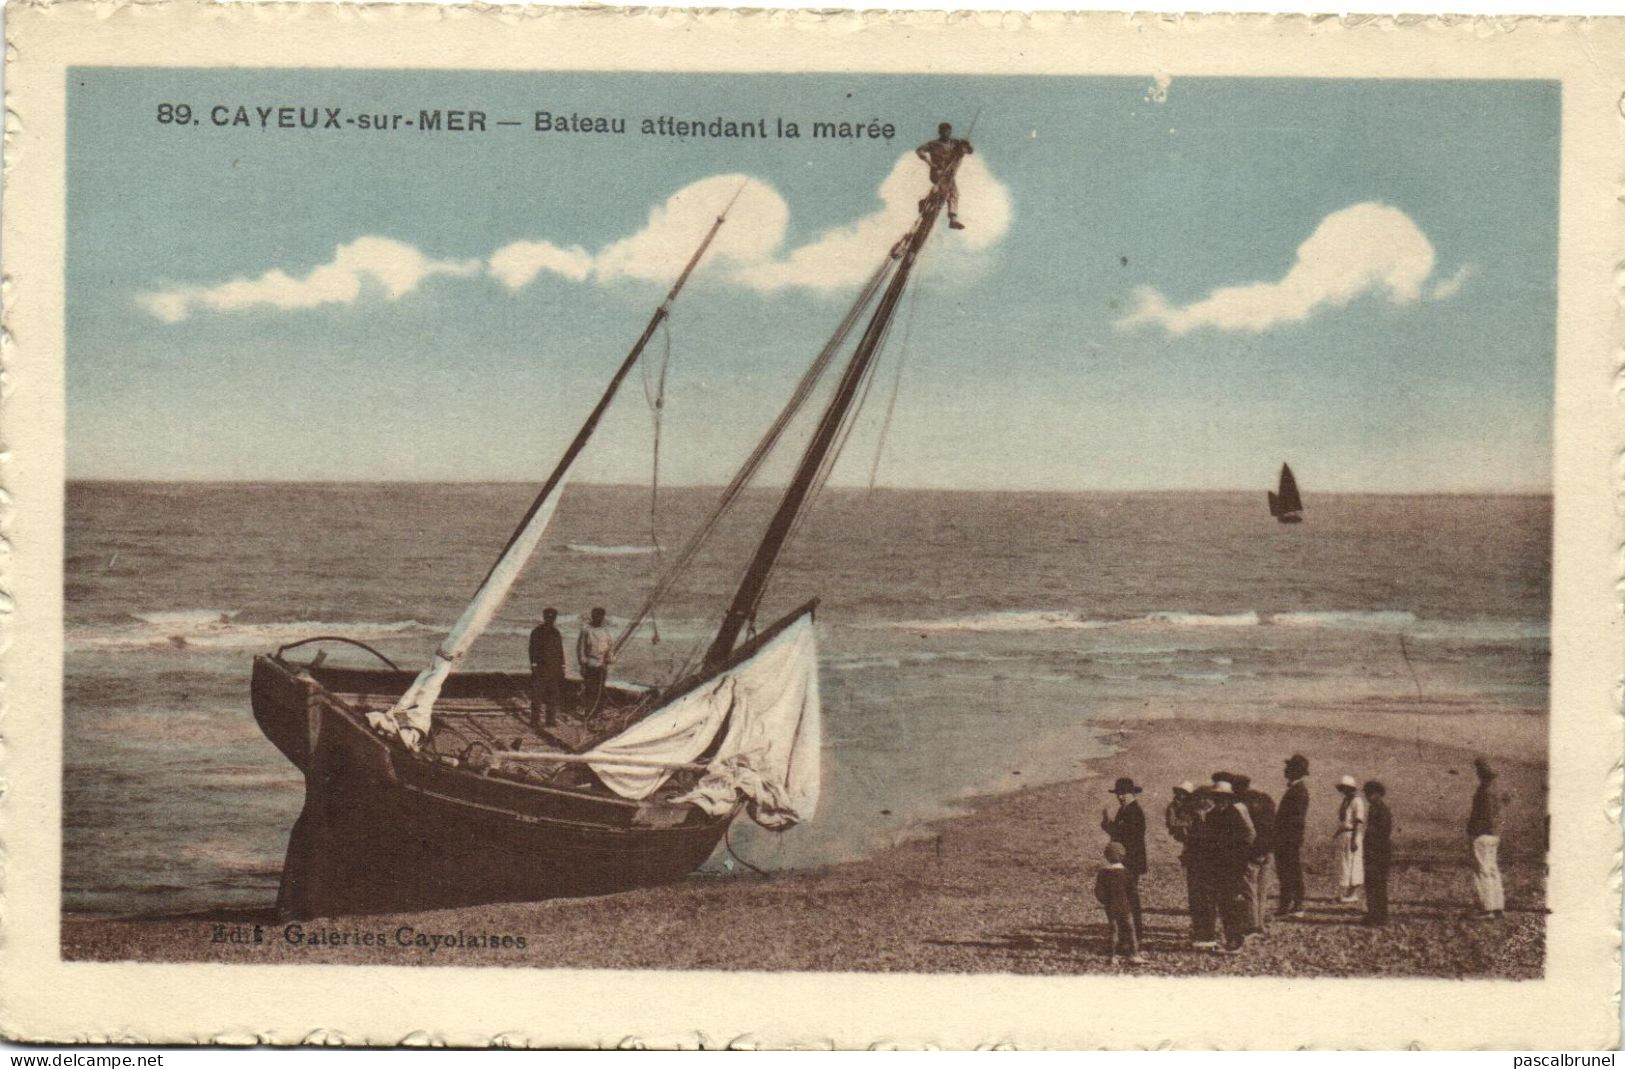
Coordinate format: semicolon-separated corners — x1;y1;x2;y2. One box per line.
62;483;1552;916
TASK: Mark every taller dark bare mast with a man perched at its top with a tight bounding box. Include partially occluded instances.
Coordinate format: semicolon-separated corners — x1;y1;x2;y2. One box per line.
705;149;964;671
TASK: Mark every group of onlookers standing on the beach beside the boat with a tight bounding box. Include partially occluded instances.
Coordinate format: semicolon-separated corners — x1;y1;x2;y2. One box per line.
1095;754;1506;965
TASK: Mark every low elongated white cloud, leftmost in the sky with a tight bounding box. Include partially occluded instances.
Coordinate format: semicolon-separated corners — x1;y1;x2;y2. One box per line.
138;236;481;323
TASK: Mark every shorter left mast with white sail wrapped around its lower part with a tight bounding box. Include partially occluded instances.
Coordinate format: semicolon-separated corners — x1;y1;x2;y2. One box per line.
369;191;744;747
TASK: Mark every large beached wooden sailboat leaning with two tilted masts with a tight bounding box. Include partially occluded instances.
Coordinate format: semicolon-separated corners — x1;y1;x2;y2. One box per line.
252;141;959;918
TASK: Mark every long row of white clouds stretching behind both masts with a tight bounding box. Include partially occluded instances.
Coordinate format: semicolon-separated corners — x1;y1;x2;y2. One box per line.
140;153;1011;323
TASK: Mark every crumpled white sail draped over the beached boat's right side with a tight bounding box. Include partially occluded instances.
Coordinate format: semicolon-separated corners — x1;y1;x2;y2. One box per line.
590;612;822;829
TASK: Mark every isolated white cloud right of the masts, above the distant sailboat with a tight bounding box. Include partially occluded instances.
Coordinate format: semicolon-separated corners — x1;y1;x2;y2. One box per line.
1115;201;1466;335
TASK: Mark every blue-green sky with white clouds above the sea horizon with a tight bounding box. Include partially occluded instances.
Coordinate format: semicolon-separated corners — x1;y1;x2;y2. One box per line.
67;68;1560;494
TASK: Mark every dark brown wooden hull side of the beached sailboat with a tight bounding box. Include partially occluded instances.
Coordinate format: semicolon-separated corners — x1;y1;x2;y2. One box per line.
252;656;733;918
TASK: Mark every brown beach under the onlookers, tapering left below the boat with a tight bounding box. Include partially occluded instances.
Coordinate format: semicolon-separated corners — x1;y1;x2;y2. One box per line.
62;703;1545;978
